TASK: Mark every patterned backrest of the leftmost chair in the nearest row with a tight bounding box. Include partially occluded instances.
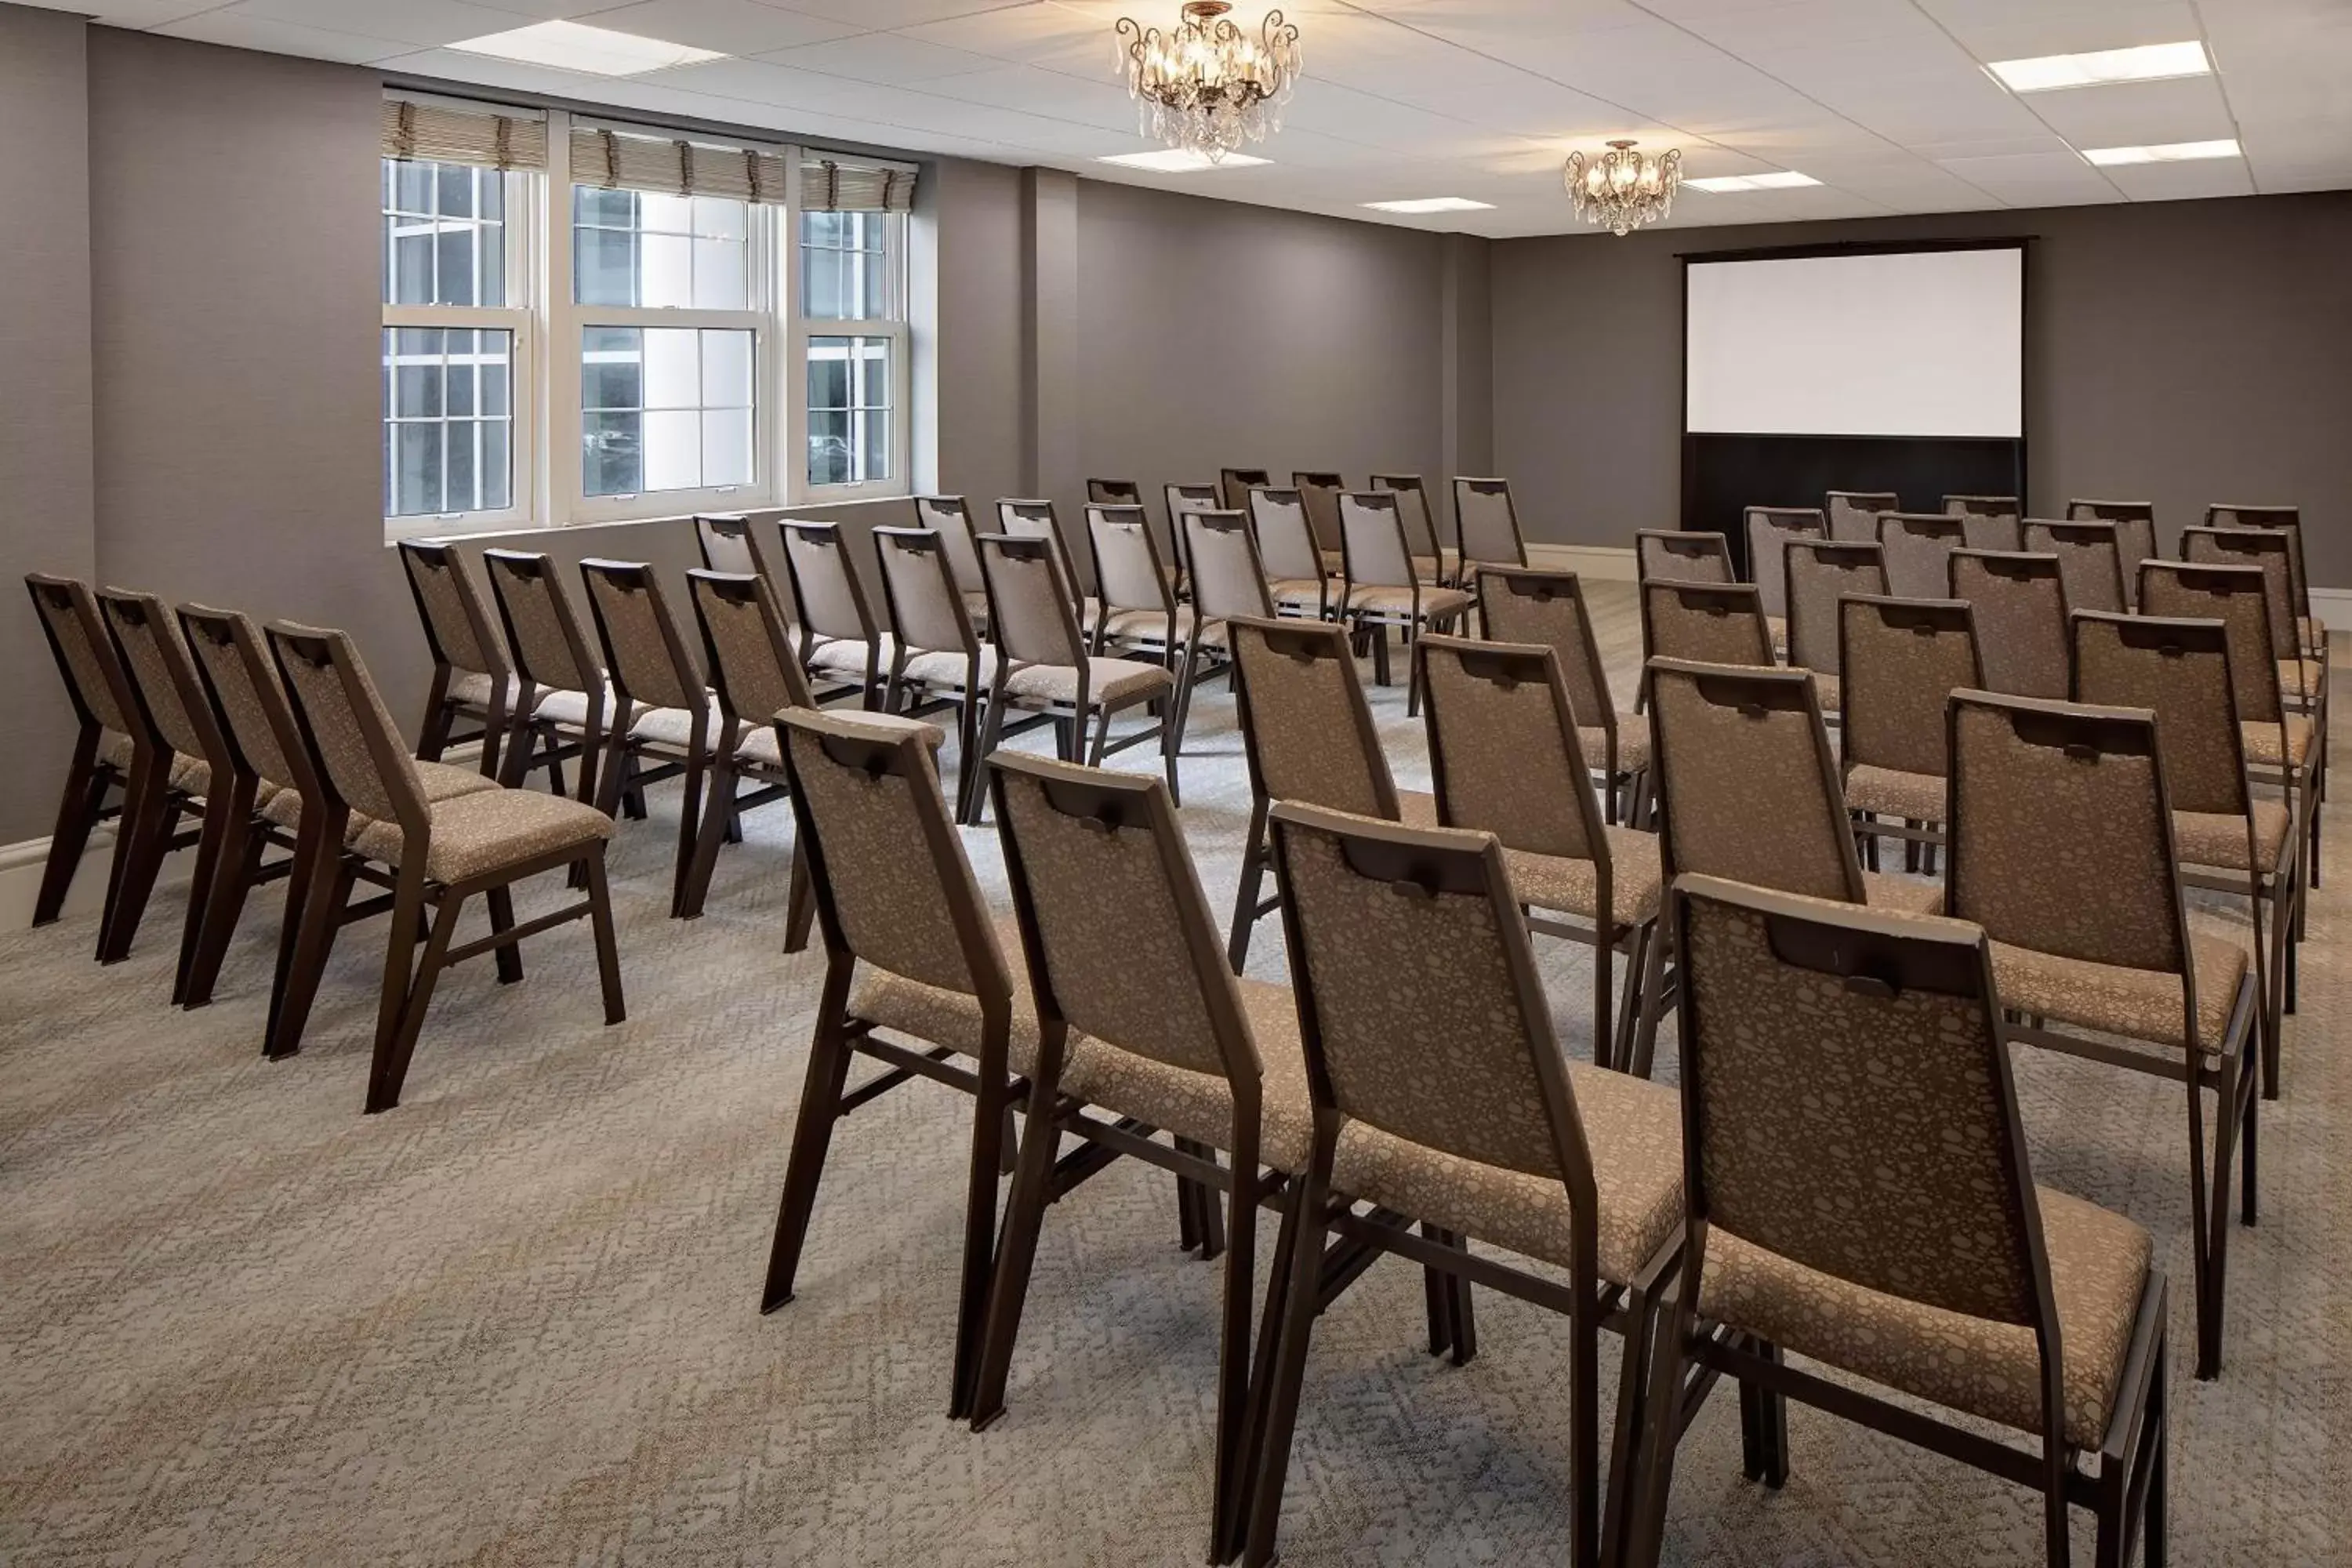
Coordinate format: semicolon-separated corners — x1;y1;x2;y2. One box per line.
776;708;1011;1008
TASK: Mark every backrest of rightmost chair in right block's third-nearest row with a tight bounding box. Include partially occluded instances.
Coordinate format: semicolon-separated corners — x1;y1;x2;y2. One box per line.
2072;609;2251;815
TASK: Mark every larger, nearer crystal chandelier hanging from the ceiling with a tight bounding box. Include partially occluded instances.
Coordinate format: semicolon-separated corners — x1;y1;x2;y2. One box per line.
1112;0;1298;162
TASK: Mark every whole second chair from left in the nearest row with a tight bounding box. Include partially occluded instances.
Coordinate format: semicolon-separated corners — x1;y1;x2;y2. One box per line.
971;752;1312;1561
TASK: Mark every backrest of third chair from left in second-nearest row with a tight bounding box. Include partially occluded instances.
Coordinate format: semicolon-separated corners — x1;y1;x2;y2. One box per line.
1649;659;1863;902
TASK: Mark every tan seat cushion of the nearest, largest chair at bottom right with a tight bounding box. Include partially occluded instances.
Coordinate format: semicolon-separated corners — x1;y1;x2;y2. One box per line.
1698;1187;2154;1448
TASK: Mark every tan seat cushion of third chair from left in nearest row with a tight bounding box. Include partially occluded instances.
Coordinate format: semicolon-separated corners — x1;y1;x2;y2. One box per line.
1331;1062;1682;1283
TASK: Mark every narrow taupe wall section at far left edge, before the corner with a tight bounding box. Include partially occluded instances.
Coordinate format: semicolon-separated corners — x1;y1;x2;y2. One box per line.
0;5;94;844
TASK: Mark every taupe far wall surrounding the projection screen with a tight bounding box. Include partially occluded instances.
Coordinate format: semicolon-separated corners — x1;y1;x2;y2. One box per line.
1494;193;2352;586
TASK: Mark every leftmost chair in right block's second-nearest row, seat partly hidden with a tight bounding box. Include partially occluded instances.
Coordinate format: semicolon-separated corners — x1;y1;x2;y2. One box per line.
1225;616;1437;973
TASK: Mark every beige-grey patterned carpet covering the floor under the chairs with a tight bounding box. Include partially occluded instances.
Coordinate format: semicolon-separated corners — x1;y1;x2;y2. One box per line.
0;590;2352;1568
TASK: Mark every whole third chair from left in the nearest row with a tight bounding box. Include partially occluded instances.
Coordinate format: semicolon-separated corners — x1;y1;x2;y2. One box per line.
1242;801;1682;1568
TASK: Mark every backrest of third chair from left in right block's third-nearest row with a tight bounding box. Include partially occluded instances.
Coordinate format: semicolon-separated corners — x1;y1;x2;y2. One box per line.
1837;595;1985;779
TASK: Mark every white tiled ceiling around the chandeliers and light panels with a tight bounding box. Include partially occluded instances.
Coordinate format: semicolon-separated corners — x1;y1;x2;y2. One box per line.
35;0;2352;235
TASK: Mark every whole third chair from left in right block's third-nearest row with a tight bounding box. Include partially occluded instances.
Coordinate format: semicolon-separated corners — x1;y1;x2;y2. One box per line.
1837;595;1985;872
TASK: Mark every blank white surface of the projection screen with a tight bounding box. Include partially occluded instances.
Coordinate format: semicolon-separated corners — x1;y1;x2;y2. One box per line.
1684;247;2025;437
